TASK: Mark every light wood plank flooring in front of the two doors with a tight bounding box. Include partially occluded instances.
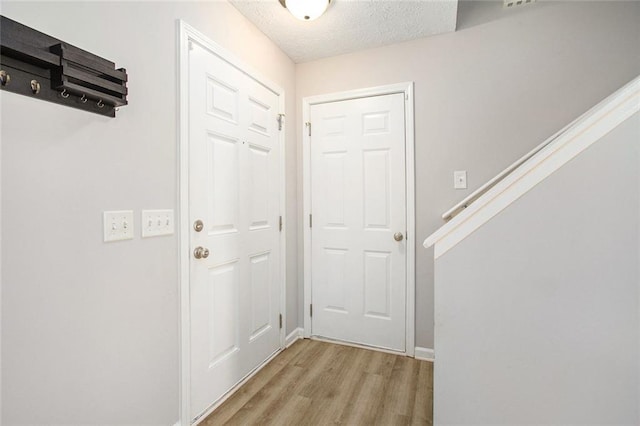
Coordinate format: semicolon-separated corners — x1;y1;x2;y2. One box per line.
201;339;433;426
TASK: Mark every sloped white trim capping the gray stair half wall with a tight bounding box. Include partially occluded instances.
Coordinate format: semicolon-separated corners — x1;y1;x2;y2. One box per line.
424;77;640;259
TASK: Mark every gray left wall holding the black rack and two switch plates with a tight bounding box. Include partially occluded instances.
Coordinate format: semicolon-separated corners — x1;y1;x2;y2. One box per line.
1;1;298;425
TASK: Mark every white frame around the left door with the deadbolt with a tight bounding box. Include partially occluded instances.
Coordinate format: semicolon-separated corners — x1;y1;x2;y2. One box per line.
177;20;287;426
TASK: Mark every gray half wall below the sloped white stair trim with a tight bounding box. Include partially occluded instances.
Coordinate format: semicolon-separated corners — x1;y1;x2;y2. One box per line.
434;113;640;425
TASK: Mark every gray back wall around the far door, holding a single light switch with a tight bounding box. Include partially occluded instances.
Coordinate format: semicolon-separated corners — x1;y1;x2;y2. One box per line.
297;1;640;350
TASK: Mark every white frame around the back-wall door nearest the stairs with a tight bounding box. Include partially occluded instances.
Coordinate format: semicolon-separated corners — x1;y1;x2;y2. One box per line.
302;81;416;356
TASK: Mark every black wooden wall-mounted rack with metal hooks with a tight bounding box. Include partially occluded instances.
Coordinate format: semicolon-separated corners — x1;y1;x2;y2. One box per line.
0;16;128;117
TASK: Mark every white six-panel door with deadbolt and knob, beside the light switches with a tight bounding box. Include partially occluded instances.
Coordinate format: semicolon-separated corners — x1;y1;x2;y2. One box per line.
189;43;281;419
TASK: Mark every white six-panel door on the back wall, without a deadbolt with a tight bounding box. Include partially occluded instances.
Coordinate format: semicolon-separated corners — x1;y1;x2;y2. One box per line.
310;93;406;351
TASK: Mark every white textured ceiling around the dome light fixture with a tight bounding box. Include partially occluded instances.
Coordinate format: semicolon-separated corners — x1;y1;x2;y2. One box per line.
229;0;458;63
